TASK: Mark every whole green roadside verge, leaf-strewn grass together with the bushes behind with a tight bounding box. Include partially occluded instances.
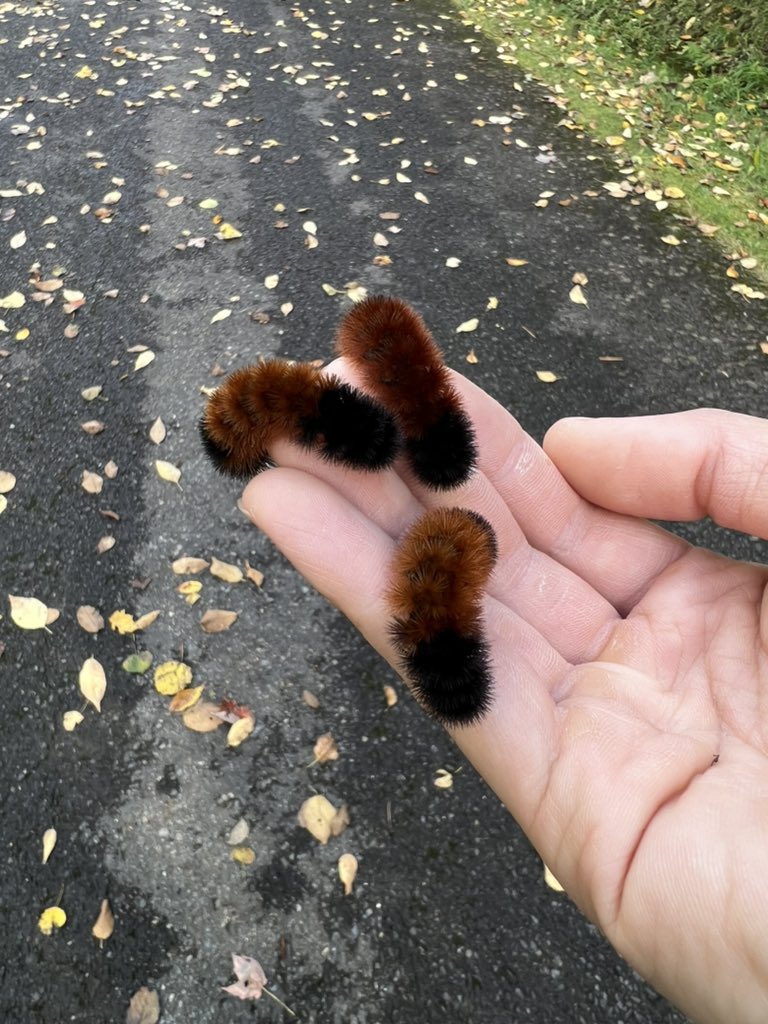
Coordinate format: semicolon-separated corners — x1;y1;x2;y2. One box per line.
453;0;768;297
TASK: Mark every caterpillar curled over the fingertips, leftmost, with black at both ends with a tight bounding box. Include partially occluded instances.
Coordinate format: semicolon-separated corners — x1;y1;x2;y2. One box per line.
200;359;399;478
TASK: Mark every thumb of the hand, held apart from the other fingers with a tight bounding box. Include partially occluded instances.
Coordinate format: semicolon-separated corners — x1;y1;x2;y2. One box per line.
545;409;768;538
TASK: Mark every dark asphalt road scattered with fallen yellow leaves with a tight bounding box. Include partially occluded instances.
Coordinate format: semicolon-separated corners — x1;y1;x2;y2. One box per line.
0;0;767;1024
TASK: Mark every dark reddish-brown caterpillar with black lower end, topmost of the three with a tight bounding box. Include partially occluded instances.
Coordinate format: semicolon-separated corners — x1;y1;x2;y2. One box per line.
336;296;477;490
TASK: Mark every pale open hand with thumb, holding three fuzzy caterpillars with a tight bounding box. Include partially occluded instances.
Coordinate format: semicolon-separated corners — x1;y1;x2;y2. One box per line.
243;360;768;1024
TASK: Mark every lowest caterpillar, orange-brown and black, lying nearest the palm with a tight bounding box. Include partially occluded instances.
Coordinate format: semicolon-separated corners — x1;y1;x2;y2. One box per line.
386;508;497;725
